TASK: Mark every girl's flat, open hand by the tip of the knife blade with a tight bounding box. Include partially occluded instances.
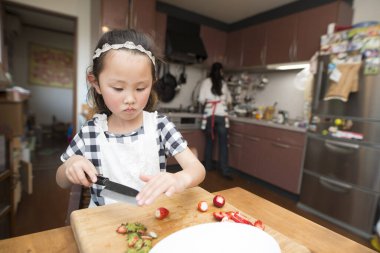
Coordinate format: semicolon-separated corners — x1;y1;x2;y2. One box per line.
136;171;191;206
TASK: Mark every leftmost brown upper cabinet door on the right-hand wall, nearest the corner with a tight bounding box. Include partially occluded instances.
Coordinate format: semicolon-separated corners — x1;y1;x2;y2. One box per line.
226;30;243;68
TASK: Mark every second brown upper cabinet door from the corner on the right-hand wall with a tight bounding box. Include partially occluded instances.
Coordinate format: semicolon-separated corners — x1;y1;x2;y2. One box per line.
243;23;266;66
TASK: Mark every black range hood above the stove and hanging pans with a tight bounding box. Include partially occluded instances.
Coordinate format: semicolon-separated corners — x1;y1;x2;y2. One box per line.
165;16;207;64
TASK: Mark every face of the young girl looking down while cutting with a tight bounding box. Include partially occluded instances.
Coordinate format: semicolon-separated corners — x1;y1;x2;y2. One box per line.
94;50;153;120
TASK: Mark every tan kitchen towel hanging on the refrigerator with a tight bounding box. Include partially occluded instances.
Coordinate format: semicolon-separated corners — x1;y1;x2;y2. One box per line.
324;63;361;102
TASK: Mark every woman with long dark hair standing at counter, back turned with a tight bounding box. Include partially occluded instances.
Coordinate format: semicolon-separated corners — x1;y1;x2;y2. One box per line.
198;62;232;179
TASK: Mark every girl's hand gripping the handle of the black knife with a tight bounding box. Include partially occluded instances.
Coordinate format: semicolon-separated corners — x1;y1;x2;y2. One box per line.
64;155;98;187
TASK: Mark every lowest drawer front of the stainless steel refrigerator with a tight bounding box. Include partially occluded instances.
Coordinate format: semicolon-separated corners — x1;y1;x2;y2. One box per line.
300;171;378;234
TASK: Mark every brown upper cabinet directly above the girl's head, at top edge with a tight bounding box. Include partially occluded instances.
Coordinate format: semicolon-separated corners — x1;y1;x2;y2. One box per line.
102;0;156;37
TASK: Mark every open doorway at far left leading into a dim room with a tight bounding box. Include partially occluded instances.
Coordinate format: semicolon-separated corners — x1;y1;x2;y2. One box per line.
0;1;78;236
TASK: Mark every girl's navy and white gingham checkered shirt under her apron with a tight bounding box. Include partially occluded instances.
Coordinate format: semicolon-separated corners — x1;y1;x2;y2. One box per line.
61;112;187;205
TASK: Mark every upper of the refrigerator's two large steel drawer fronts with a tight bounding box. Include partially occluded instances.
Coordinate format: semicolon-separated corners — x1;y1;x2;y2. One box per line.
304;134;380;192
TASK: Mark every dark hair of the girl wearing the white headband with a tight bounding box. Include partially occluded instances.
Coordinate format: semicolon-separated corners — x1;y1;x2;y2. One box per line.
87;29;158;116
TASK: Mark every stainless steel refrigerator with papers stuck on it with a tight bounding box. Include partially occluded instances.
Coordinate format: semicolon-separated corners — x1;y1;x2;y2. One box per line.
298;25;380;238
